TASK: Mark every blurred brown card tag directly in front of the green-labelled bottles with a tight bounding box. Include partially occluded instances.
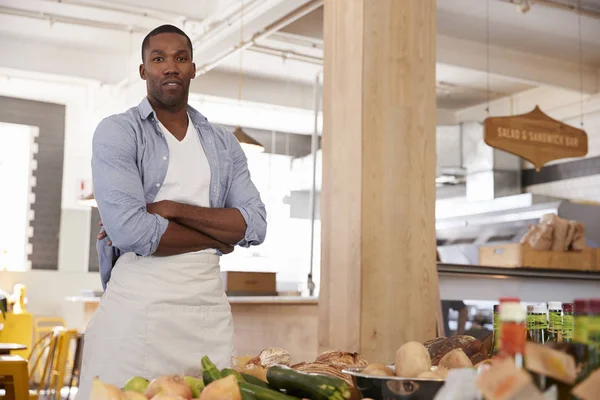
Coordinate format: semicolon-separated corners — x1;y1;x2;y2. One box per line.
525;342;577;384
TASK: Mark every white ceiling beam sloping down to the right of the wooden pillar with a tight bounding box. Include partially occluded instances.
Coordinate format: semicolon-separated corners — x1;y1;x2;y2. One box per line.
437;35;600;94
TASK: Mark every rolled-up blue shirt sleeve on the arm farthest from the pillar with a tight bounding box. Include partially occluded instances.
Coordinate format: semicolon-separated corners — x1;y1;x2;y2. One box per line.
92;117;169;257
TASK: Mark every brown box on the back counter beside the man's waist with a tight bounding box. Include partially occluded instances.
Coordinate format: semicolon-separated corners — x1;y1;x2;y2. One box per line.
221;271;277;296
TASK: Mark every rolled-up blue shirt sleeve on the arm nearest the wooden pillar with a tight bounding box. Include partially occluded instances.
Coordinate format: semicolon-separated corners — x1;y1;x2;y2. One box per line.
225;133;267;247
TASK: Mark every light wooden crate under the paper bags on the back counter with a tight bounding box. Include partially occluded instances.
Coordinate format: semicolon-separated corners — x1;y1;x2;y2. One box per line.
479;243;600;271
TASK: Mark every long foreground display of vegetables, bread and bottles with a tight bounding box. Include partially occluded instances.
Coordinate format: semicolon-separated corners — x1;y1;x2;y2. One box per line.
85;298;600;400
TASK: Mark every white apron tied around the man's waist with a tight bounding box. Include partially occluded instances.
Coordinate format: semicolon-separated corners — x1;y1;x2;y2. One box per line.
76;253;234;400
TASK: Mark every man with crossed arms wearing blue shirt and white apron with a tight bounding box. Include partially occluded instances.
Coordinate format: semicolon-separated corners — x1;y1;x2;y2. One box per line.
77;25;266;400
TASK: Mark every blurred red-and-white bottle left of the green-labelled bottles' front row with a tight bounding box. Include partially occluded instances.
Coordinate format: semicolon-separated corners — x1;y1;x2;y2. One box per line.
500;302;527;368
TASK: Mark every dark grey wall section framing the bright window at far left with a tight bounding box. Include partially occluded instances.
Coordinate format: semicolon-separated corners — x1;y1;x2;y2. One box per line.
0;96;65;270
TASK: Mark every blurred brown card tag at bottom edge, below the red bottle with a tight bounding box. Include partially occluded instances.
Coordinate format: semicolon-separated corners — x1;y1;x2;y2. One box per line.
477;358;544;400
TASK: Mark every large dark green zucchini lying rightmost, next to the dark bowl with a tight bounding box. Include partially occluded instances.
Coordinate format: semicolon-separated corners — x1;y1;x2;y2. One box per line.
267;365;351;400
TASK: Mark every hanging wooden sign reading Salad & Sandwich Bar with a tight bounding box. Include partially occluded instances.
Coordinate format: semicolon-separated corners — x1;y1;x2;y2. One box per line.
484;106;588;171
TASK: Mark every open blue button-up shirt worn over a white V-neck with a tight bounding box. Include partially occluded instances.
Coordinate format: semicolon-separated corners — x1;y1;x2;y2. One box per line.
92;98;267;290
